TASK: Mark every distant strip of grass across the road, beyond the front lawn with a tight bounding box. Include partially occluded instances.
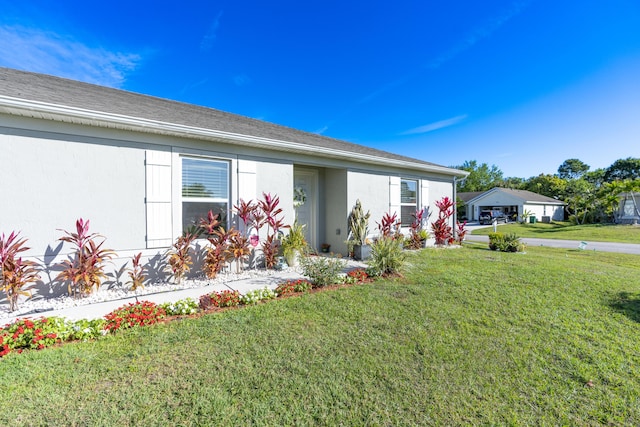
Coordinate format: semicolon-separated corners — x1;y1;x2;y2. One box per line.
471;222;640;243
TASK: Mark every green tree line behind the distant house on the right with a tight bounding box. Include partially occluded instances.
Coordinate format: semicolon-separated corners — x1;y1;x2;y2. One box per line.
453;157;640;224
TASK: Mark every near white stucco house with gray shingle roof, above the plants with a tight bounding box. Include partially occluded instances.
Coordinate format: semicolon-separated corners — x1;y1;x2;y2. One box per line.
0;68;467;288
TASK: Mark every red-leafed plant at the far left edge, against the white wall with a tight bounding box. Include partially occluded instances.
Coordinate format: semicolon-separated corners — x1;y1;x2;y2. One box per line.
0;232;40;311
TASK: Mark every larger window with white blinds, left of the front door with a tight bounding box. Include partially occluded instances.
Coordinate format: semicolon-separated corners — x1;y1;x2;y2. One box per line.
182;157;229;231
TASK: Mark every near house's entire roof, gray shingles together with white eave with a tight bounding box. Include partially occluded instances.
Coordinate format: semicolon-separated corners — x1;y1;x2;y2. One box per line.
0;67;468;177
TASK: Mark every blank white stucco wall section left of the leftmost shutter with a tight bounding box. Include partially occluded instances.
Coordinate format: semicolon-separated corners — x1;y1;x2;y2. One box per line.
0;130;145;257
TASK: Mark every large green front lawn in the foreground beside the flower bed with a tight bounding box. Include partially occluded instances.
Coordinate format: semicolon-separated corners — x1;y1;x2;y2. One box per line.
0;249;640;426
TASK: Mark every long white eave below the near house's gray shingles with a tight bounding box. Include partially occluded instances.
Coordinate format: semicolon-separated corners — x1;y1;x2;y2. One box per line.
0;95;469;177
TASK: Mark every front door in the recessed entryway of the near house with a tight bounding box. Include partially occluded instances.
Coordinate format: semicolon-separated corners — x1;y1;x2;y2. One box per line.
293;169;318;249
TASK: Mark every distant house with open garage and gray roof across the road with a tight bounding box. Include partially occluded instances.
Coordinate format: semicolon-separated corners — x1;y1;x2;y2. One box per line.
458;187;565;222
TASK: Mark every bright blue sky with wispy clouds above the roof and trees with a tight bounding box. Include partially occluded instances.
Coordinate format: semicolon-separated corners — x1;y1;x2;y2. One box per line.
0;0;640;178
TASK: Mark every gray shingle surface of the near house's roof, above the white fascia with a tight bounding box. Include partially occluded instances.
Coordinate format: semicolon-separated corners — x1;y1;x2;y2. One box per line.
0;67;464;176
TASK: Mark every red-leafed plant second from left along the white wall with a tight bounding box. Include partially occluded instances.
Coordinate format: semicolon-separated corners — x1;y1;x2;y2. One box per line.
57;218;115;296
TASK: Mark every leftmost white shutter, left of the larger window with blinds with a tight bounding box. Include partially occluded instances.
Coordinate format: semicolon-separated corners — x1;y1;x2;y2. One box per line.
146;150;173;248
